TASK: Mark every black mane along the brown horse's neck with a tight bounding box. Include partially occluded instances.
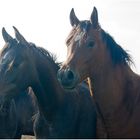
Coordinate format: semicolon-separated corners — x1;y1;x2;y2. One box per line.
102;30;133;65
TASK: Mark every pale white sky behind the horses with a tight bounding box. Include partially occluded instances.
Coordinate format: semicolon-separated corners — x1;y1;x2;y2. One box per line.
0;0;140;74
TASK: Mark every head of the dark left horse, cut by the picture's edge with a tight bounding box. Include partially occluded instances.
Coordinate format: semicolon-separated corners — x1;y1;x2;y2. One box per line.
0;27;37;99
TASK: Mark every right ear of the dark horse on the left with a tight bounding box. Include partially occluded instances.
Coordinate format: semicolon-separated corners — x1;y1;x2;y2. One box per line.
13;26;28;45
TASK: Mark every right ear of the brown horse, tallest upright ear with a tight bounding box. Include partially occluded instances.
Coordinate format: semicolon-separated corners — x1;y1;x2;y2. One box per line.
90;7;99;28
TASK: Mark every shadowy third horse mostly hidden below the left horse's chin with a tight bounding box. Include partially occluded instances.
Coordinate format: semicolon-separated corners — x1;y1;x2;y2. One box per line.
0;89;38;139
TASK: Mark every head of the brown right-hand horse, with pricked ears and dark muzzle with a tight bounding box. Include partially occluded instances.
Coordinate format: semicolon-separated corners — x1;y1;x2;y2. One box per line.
58;7;103;88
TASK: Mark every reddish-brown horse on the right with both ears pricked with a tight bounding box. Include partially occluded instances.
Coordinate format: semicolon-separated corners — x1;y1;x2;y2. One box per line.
58;7;140;138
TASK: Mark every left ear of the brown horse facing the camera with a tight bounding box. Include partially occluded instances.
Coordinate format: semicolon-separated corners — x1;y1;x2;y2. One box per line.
70;8;80;26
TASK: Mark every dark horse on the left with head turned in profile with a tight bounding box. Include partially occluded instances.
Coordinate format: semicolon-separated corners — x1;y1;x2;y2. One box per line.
0;27;96;138
